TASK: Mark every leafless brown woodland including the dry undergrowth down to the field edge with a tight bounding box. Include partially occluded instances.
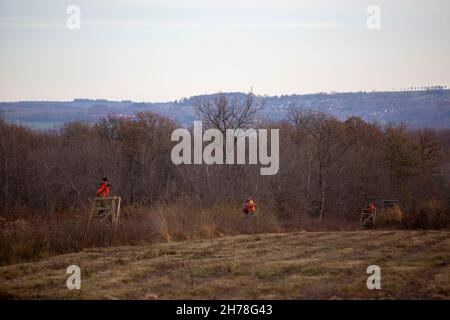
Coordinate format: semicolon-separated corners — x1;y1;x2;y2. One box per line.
0;95;450;264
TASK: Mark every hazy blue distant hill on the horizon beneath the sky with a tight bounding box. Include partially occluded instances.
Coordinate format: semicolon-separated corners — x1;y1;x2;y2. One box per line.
0;89;450;128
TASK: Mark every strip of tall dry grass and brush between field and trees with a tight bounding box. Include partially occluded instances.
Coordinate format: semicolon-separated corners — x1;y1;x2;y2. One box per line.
0;200;449;265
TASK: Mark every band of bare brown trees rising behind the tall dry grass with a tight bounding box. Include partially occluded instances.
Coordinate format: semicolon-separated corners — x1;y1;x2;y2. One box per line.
0;97;450;224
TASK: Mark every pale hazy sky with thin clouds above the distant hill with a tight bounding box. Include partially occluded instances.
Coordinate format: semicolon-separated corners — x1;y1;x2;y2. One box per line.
0;0;450;101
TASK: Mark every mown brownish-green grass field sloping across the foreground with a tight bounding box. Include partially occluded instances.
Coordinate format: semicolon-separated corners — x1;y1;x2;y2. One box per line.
0;231;450;299
